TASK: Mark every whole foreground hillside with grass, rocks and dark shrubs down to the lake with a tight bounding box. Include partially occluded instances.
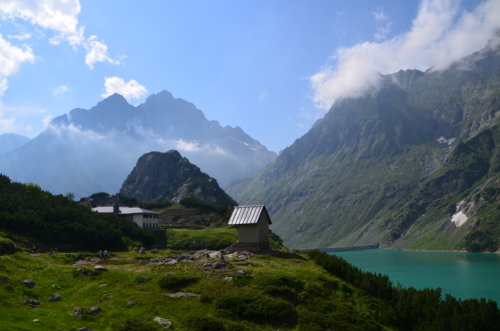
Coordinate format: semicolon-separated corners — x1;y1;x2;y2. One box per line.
0;251;500;331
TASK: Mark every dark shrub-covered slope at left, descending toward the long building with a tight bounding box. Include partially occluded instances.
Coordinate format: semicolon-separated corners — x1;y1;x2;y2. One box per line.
0;175;154;251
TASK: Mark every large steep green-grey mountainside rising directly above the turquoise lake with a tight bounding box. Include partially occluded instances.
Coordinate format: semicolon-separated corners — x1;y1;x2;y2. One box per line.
228;36;500;252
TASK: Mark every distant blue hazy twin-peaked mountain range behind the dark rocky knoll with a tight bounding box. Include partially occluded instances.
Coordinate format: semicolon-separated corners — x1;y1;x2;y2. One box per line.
0;91;275;196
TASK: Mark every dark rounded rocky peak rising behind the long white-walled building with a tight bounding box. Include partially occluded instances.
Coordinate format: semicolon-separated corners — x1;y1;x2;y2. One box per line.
120;150;236;205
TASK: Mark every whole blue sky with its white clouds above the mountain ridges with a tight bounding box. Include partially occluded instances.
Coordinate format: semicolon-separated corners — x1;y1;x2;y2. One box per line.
0;0;500;152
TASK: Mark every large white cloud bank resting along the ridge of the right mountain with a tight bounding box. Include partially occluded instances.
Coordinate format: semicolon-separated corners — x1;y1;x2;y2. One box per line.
310;0;500;109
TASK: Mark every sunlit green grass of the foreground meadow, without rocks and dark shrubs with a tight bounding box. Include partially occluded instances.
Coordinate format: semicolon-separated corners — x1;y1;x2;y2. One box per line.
0;251;390;330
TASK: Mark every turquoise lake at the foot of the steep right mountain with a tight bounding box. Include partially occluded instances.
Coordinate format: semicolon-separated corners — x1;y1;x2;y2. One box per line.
330;249;500;306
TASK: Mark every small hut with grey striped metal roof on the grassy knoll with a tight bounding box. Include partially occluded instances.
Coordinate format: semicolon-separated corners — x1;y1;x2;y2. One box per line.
228;205;272;251
